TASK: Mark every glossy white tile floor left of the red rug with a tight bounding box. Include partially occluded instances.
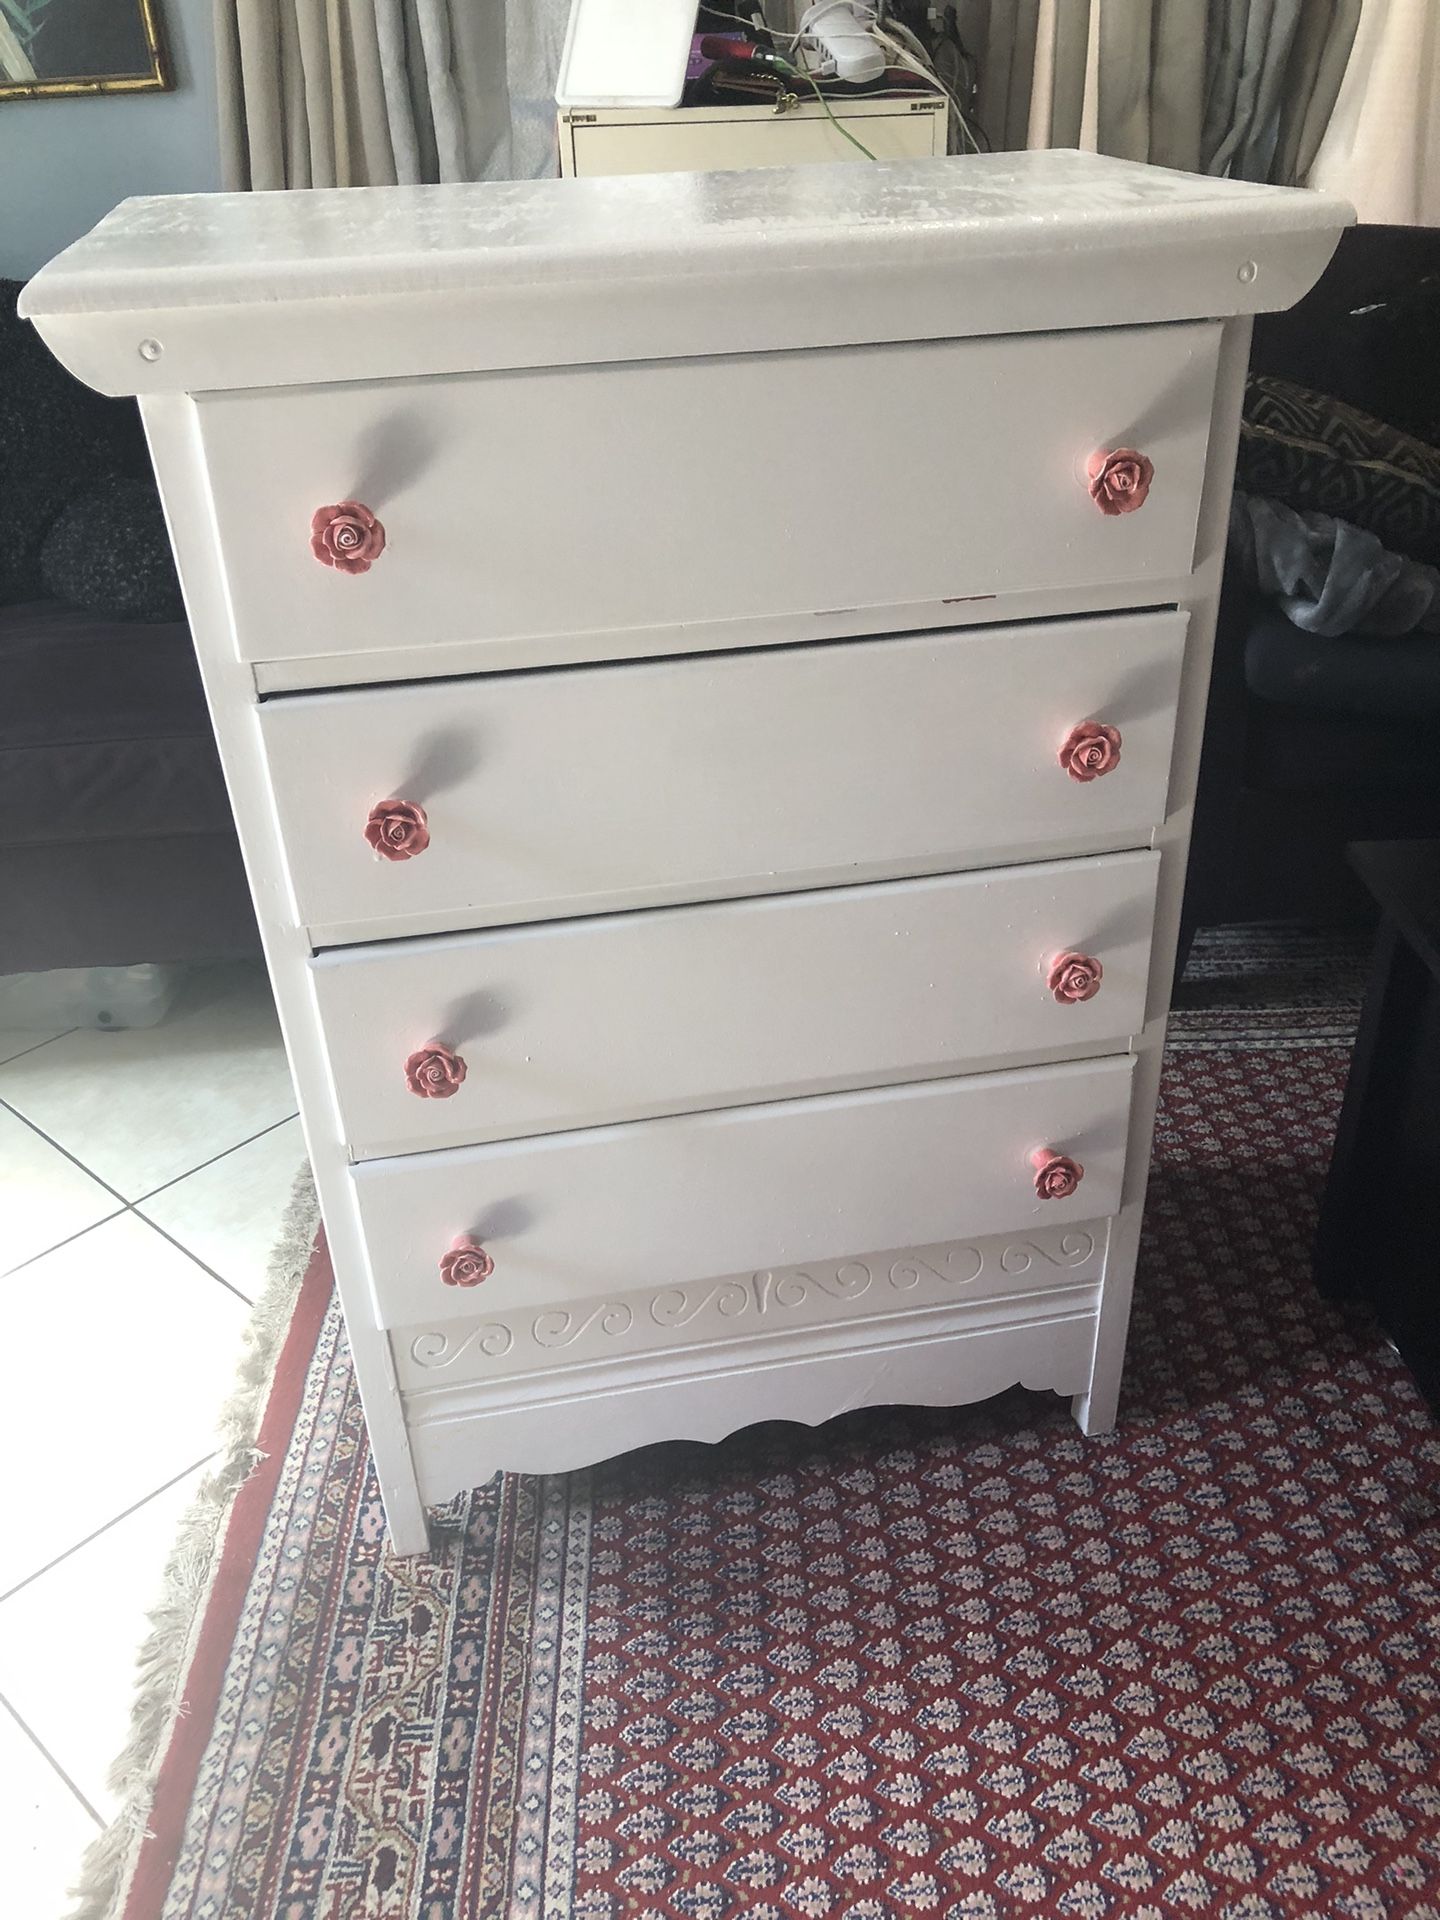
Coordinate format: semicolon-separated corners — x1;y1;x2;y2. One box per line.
0;964;305;1920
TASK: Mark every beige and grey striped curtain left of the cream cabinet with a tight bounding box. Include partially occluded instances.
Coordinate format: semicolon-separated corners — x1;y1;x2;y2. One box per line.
215;0;568;188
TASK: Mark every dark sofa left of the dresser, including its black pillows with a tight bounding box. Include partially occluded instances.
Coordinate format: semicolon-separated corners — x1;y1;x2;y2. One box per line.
0;268;257;973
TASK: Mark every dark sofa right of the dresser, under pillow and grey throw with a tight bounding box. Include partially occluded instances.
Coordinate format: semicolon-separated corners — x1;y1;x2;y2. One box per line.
1185;227;1440;933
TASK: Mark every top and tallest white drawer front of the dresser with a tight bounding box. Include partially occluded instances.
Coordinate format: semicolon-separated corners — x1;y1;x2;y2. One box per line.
196;323;1219;660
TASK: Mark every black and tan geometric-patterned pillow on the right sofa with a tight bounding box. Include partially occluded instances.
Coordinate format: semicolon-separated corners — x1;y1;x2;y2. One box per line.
1235;374;1440;566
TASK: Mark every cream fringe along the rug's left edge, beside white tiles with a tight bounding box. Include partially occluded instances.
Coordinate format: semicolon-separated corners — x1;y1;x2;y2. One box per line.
65;1167;321;1920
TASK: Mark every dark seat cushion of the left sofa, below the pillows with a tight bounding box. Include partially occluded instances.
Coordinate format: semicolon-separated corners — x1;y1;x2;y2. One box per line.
0;601;234;847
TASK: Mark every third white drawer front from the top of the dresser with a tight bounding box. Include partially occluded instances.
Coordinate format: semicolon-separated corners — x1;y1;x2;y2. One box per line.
311;852;1160;1160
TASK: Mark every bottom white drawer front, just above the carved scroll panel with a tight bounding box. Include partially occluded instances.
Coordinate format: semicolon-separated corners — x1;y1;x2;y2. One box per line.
351;1056;1133;1327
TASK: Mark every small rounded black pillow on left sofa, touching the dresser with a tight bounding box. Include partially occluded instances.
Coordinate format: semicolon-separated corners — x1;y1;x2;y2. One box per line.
40;480;184;620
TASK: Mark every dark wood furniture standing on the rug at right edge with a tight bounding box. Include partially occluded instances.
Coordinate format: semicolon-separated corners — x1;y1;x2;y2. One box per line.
1315;841;1440;1411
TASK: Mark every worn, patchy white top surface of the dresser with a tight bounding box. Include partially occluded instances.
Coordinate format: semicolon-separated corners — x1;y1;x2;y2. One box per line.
27;150;1334;315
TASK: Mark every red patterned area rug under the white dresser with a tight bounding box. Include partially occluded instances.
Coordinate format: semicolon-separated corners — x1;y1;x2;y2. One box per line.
90;929;1440;1920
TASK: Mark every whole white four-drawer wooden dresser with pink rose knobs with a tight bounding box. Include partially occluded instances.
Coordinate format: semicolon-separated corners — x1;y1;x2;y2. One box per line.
21;154;1350;1551
